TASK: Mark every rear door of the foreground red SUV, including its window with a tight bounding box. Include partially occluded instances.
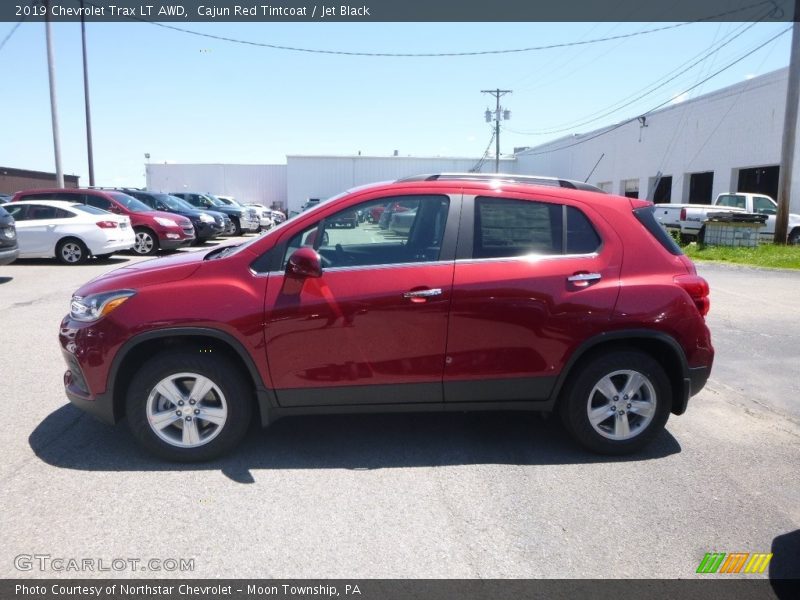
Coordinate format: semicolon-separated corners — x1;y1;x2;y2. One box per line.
444;194;622;402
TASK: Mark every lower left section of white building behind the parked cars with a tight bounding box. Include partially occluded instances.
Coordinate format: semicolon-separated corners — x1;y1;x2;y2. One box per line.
145;164;286;207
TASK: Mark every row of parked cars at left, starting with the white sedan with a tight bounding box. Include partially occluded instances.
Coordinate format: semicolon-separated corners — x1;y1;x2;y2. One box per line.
0;188;285;265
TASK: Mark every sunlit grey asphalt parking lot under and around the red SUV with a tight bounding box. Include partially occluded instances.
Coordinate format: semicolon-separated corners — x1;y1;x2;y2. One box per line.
0;245;800;578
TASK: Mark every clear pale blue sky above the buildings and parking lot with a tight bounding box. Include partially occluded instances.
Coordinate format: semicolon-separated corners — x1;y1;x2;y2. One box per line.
0;22;791;186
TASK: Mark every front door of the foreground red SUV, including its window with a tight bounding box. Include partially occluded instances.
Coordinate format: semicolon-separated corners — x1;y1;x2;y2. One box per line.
265;195;460;406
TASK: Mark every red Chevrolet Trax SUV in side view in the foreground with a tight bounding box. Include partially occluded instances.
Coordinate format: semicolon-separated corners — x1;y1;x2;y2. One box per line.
60;175;714;461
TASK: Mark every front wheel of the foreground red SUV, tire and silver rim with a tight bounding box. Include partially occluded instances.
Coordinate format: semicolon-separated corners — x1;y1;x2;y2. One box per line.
126;349;253;462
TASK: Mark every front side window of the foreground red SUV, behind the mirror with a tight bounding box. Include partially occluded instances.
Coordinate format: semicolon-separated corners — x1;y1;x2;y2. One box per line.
283;196;450;268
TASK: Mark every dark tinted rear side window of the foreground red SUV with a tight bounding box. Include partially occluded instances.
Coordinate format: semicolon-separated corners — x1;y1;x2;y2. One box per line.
472;198;601;258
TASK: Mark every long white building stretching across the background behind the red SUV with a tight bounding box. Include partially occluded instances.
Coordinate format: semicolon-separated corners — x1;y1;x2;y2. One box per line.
146;68;800;212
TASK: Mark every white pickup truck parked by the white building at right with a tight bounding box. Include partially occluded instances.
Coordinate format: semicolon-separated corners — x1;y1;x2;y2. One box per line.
656;192;800;244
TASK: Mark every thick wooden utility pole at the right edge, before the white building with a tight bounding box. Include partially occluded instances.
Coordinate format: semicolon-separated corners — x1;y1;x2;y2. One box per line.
773;0;800;244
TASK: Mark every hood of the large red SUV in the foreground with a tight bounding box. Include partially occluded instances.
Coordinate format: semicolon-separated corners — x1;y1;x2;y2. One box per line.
75;251;208;296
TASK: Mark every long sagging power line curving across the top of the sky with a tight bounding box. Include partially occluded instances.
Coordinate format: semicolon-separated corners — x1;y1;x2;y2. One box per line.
72;0;780;58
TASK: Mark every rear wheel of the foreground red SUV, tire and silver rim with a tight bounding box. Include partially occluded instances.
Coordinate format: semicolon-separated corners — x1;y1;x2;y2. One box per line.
559;349;672;455
